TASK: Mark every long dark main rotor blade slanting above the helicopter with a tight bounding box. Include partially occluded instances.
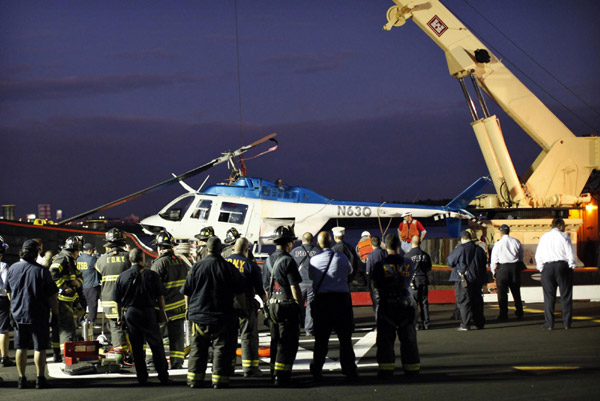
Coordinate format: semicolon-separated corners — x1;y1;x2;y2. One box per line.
58;133;277;225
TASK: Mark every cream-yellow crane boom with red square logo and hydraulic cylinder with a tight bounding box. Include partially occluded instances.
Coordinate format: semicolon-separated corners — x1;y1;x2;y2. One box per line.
384;0;600;207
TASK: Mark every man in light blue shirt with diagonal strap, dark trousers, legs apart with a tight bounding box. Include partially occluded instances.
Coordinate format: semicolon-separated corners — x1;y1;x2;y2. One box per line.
309;231;358;381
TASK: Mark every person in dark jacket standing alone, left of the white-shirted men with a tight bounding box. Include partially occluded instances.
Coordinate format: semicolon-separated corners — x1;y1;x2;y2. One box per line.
448;230;487;331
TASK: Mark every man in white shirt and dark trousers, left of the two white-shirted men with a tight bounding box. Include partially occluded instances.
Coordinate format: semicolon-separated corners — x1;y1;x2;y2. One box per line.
490;224;523;320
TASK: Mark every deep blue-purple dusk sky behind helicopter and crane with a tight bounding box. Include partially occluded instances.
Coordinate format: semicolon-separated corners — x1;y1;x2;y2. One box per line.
0;0;600;217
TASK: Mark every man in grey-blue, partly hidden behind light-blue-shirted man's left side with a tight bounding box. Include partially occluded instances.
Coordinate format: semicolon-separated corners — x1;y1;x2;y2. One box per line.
291;232;321;336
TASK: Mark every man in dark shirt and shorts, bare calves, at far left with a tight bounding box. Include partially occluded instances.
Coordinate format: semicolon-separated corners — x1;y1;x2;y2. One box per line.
6;240;58;388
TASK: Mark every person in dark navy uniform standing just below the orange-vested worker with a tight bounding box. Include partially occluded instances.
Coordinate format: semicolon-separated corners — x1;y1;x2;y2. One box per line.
404;235;431;330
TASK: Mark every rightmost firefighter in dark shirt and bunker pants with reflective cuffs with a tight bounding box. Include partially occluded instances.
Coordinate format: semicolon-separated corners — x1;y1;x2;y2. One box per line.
372;234;420;379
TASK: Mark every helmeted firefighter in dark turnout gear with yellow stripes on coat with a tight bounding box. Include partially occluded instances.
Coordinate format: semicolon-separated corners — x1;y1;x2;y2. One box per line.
152;231;188;369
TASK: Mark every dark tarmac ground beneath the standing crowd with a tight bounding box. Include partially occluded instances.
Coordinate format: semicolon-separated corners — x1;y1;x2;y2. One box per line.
0;302;600;401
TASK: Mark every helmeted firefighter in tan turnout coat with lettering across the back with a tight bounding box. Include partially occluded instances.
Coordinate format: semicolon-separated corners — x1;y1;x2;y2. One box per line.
96;228;131;346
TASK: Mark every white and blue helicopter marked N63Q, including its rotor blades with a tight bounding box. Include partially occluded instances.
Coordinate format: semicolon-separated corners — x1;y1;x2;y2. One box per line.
59;134;489;245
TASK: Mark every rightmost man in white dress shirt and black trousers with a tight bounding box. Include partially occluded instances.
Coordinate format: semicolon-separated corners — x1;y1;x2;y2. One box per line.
535;217;577;330
